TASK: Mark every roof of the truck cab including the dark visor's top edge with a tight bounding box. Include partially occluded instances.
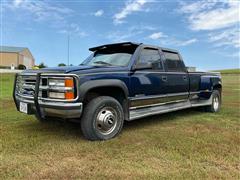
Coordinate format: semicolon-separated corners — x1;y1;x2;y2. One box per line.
89;42;178;53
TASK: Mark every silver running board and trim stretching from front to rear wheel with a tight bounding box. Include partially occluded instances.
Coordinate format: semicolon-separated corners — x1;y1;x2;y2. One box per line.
129;97;212;121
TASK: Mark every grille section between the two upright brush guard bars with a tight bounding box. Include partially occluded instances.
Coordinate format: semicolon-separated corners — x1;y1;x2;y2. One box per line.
16;75;36;98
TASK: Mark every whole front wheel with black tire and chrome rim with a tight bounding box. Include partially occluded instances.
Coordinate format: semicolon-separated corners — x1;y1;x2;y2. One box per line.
81;96;124;140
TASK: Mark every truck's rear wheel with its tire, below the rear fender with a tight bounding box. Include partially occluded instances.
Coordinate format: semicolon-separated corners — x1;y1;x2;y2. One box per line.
205;90;221;113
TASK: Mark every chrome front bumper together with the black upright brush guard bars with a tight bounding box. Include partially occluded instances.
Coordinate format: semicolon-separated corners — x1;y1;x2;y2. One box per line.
13;74;83;119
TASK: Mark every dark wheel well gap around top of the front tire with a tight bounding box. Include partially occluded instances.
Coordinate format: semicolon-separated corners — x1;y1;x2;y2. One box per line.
83;86;129;119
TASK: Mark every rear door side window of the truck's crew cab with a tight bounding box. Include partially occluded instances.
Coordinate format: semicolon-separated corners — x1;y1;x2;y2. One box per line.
163;51;184;72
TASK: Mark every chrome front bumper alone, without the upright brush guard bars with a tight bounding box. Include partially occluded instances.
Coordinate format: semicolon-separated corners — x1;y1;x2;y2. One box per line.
15;96;83;119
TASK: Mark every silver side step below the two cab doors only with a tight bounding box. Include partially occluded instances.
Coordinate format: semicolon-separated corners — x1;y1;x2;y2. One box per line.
129;100;192;121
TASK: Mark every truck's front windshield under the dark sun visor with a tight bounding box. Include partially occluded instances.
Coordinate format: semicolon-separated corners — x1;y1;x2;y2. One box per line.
81;47;135;66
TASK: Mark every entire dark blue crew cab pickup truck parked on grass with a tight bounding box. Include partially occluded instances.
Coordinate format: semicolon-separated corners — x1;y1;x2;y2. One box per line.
13;42;222;140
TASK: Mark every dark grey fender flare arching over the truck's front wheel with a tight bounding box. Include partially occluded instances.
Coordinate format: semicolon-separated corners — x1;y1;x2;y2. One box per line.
79;79;129;101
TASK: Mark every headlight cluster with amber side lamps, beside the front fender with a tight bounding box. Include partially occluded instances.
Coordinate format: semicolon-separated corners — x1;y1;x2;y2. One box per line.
48;77;75;100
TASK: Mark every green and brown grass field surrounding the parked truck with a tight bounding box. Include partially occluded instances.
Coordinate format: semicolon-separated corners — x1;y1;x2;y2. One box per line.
0;74;240;179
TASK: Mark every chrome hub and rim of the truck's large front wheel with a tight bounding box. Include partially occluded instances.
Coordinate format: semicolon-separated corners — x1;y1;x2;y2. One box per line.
96;107;117;135
